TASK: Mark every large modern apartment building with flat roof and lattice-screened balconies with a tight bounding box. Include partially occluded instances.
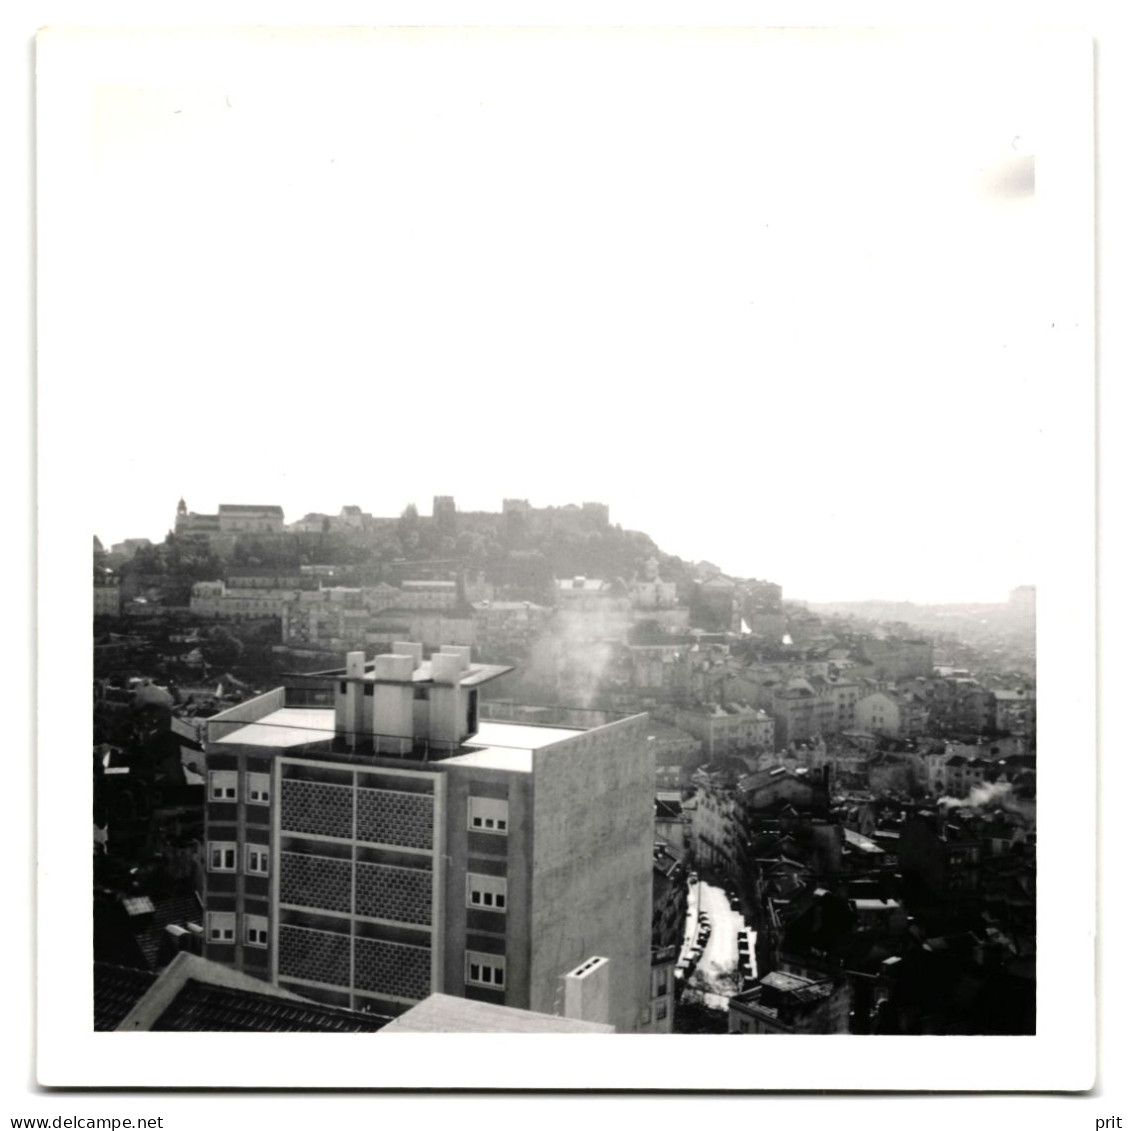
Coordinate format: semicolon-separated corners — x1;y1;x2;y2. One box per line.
202;644;655;1031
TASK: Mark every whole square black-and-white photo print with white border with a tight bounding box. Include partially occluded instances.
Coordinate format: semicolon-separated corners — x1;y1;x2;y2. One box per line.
28;11;1114;1103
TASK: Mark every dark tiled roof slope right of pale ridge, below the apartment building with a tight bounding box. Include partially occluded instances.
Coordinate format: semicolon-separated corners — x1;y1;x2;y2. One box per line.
153;978;389;1033
